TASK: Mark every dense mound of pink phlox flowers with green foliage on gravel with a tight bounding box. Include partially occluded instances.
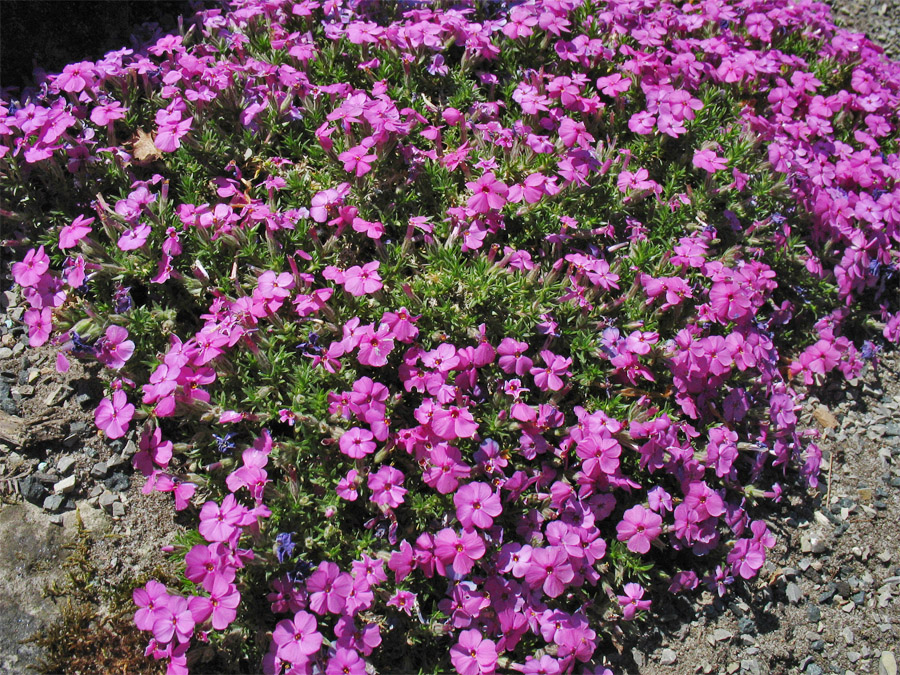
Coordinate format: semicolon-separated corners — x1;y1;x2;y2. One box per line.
0;0;900;675
